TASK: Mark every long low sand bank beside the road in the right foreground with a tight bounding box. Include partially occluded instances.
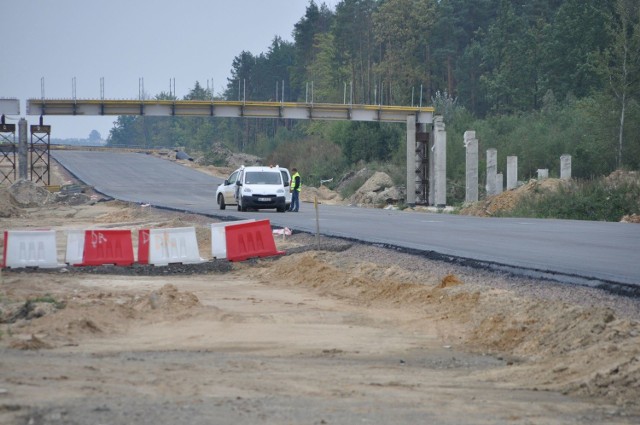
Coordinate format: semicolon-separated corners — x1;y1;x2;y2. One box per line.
249;252;640;405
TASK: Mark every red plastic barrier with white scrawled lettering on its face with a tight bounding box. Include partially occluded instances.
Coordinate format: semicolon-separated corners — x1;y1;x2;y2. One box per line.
81;230;133;266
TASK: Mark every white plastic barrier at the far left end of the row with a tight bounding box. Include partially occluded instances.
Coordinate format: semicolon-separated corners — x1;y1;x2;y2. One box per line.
2;230;60;268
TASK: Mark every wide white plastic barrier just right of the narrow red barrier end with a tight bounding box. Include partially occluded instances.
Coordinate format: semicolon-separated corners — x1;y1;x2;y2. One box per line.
149;227;205;266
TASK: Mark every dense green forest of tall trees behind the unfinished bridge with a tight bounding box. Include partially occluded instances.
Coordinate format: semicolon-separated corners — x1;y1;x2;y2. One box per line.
108;0;640;202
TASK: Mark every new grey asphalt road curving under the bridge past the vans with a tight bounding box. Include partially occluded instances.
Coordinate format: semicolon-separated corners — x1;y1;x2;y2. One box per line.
51;151;640;293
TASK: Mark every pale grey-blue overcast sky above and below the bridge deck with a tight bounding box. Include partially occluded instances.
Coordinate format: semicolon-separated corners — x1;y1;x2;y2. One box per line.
0;0;339;139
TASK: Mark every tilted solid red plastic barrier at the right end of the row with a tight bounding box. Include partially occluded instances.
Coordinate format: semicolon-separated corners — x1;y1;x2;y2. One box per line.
225;220;285;261
